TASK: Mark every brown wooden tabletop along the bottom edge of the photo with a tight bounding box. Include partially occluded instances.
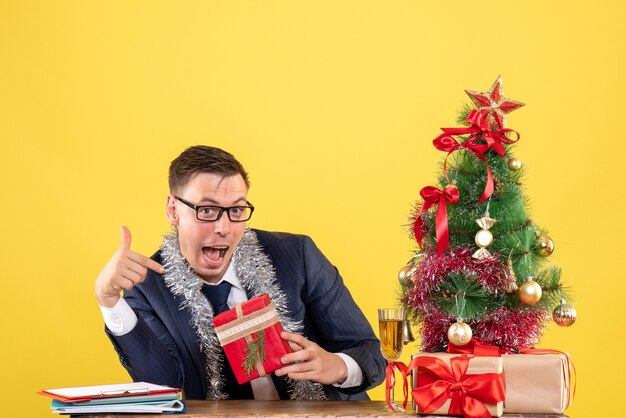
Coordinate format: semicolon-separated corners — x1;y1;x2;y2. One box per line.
75;400;567;418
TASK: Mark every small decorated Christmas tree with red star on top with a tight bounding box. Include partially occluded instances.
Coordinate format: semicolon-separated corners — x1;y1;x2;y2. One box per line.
399;77;576;352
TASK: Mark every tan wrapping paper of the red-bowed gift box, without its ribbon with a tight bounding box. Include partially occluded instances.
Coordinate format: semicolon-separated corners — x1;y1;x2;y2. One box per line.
411;353;504;417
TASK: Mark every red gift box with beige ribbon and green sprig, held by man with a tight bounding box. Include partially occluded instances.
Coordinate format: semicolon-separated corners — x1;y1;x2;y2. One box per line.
213;294;291;384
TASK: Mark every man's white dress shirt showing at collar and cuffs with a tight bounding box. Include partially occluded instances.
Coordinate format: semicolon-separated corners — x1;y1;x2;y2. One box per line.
100;263;363;400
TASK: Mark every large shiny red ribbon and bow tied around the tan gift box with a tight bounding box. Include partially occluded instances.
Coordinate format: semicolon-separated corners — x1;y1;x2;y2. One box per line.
408;354;505;418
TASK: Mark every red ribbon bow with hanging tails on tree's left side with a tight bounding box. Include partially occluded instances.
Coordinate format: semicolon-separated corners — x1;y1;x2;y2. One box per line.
413;186;459;255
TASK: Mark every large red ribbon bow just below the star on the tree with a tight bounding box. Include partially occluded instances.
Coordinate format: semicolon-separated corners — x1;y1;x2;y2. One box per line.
433;110;520;203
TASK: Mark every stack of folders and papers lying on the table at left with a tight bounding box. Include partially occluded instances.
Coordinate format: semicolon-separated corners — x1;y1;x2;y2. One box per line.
38;382;185;414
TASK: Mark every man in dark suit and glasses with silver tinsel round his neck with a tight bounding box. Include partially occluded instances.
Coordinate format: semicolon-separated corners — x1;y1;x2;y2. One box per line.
95;146;385;399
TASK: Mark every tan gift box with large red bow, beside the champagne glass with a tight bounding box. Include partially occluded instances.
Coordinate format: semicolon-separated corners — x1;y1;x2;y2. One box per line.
408;353;505;417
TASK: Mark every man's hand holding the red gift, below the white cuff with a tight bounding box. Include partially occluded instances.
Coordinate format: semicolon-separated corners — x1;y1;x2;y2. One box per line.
275;331;348;385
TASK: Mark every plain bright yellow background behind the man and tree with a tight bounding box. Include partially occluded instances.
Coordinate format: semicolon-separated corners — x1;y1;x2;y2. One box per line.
0;0;626;418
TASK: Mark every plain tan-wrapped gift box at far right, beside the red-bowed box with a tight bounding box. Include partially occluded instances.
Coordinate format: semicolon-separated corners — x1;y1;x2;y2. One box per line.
502;350;574;414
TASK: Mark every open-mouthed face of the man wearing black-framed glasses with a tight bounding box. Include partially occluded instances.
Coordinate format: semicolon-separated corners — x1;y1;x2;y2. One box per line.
167;173;248;283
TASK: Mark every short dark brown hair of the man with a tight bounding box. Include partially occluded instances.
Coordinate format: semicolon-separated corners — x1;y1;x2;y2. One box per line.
169;145;250;193
